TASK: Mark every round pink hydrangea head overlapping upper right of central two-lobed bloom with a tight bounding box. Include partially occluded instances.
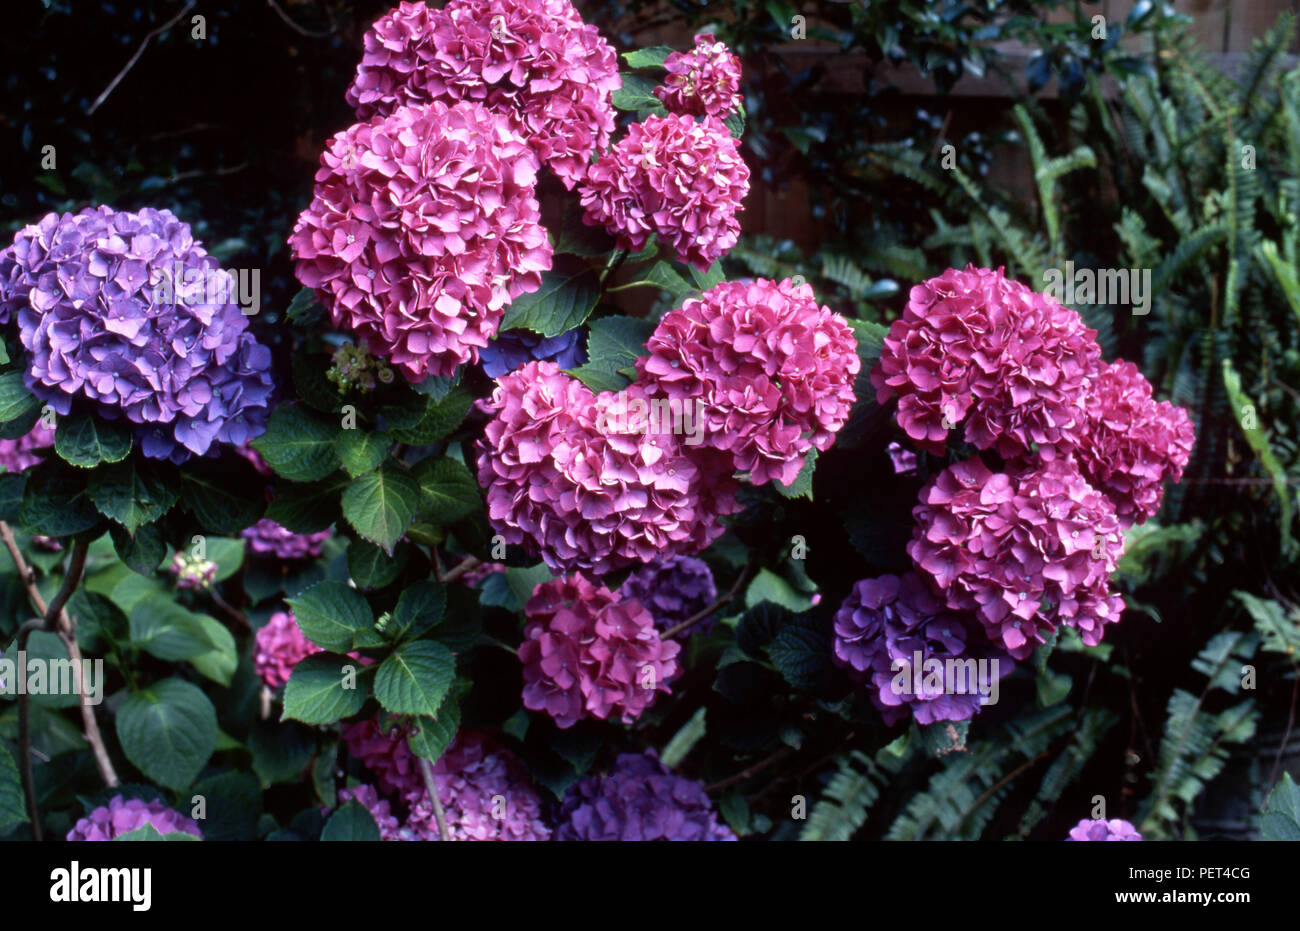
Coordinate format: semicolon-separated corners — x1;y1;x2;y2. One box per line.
637;278;861;485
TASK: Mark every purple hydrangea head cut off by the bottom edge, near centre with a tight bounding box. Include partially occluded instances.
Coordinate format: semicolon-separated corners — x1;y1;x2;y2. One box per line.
555;750;736;840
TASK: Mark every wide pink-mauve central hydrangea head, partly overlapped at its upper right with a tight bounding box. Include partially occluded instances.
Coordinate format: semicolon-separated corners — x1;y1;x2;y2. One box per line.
478;361;738;575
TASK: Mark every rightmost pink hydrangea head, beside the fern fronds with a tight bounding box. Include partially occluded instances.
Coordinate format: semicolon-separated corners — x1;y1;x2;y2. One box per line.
1060;361;1196;528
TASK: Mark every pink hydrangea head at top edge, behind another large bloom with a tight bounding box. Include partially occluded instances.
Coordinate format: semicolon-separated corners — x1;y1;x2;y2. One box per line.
347;0;623;190
